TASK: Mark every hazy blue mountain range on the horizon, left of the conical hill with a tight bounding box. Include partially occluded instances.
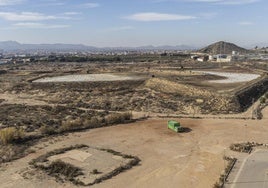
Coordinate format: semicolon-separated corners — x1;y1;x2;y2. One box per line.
0;41;197;52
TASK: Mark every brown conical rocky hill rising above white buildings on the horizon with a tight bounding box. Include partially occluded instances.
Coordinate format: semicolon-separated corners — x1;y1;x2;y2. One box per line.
198;41;250;55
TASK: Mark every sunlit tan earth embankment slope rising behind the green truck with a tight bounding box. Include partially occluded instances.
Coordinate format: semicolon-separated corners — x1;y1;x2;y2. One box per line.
145;78;239;113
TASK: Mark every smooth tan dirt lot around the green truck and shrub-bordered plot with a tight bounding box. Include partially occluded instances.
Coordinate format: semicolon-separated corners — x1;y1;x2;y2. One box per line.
0;108;268;188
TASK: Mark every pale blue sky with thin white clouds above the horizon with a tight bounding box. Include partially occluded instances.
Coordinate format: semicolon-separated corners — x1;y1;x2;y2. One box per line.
0;0;268;47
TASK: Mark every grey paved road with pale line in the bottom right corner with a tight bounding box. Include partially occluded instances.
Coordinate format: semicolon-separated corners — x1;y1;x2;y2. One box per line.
225;149;268;188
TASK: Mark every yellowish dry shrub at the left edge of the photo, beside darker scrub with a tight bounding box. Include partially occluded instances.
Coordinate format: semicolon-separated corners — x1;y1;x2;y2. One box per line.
0;127;24;145
